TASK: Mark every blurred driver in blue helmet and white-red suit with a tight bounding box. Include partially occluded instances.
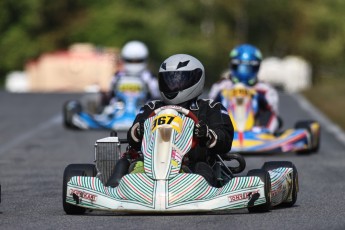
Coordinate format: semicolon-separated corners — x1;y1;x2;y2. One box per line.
209;44;282;133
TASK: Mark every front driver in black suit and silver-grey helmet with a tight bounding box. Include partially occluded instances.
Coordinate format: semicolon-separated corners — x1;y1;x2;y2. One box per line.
127;54;234;185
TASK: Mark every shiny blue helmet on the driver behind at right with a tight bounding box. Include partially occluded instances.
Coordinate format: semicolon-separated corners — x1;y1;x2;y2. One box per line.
229;44;262;86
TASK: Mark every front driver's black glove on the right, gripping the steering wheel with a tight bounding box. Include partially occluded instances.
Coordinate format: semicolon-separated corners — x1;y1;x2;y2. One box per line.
194;121;217;148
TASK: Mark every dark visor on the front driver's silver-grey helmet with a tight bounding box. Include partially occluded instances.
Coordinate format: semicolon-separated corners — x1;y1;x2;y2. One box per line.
158;68;202;93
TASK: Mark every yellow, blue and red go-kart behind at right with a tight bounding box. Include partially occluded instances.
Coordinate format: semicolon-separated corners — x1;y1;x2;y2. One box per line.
220;83;320;153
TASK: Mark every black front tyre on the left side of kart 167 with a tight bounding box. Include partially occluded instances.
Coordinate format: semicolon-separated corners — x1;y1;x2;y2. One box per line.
62;164;97;215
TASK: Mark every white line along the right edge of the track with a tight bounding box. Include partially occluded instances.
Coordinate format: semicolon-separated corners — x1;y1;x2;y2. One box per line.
290;94;345;145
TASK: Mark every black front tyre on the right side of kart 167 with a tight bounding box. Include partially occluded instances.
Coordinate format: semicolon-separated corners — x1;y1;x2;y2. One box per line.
247;169;271;212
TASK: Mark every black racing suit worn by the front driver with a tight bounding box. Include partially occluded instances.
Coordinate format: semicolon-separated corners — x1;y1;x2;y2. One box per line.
127;99;234;167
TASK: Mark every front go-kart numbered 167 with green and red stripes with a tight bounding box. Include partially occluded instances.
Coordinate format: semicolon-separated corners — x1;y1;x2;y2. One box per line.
62;106;298;214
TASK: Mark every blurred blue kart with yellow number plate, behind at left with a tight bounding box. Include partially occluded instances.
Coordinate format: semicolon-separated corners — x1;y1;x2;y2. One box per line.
63;76;147;130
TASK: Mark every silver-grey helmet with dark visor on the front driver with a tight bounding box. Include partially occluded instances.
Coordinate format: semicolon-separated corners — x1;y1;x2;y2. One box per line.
158;54;205;105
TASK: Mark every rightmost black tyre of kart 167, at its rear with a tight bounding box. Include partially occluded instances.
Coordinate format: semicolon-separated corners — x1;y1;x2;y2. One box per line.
262;161;299;207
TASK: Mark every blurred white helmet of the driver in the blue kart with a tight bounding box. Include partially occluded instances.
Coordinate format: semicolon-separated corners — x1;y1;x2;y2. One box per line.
121;41;149;75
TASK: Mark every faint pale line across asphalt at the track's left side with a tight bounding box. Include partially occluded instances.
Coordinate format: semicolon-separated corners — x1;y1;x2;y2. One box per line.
0;114;62;156
